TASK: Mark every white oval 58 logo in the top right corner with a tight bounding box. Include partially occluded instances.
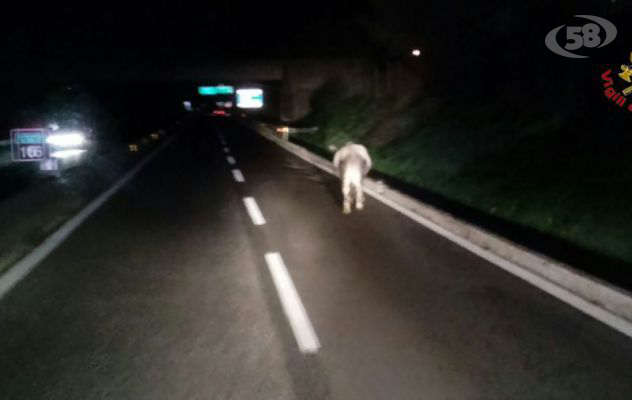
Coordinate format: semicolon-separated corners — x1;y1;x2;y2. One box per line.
544;15;617;58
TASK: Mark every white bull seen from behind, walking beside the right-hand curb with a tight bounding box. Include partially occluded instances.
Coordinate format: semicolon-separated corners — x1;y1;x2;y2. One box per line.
334;142;371;214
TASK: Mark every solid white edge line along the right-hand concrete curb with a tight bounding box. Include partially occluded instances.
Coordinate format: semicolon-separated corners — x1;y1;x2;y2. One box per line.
262;129;632;338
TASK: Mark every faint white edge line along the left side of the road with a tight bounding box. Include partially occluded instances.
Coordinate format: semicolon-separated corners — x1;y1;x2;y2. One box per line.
0;135;177;300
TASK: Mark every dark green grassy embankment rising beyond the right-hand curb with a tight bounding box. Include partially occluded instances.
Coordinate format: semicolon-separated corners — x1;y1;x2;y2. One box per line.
300;94;632;263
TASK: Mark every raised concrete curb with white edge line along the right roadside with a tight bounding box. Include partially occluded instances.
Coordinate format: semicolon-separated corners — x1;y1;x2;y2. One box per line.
249;120;632;338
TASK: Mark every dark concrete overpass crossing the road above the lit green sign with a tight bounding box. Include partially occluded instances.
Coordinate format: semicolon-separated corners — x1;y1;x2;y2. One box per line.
29;58;377;121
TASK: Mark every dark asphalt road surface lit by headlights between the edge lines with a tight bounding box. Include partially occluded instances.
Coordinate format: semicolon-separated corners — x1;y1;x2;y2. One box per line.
0;114;632;400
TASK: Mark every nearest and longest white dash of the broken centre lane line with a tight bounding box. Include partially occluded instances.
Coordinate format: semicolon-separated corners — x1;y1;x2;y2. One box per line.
265;253;320;353
